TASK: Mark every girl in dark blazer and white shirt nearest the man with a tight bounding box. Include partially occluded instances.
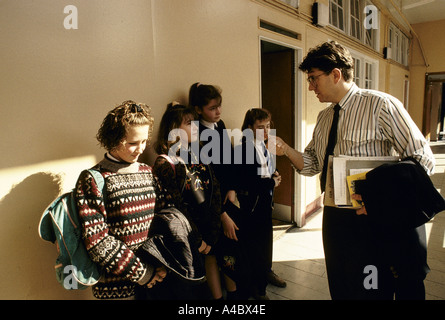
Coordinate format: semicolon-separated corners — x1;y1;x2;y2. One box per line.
235;108;285;300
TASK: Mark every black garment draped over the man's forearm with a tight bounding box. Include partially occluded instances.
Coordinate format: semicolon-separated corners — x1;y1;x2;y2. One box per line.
356;158;445;228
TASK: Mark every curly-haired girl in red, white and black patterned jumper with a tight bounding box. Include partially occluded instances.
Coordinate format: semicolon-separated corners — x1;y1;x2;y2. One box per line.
76;101;166;299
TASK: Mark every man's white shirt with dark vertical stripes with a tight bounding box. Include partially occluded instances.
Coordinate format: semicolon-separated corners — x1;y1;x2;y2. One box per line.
300;83;435;176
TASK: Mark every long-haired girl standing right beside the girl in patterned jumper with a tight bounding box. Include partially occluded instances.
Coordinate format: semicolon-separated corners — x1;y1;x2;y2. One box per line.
153;104;238;299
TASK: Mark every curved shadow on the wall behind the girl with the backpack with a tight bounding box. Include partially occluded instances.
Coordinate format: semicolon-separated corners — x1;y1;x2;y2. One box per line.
0;172;91;300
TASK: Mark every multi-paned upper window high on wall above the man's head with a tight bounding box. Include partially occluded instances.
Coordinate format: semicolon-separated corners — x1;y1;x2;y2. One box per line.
329;0;379;50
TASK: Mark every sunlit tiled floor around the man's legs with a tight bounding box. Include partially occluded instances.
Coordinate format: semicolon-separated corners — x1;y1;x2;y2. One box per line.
267;148;445;300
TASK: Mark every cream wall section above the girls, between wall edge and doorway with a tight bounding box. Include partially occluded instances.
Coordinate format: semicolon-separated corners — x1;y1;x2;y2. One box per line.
149;0;260;135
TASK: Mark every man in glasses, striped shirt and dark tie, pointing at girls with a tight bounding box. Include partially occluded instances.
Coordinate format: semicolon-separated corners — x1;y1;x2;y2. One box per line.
277;41;435;299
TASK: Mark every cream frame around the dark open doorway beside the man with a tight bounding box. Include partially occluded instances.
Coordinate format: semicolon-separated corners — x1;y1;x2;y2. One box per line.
258;36;306;227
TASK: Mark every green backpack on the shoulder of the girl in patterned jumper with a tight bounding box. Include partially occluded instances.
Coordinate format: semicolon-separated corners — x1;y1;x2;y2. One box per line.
39;169;105;290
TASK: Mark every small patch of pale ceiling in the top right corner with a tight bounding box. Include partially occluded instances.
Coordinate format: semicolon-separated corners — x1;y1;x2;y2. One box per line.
383;0;445;24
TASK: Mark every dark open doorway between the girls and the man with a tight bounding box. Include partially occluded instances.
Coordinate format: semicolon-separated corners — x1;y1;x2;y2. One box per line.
261;39;301;225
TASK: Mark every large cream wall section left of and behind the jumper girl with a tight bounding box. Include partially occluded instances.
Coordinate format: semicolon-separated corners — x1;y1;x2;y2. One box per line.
0;0;156;299
